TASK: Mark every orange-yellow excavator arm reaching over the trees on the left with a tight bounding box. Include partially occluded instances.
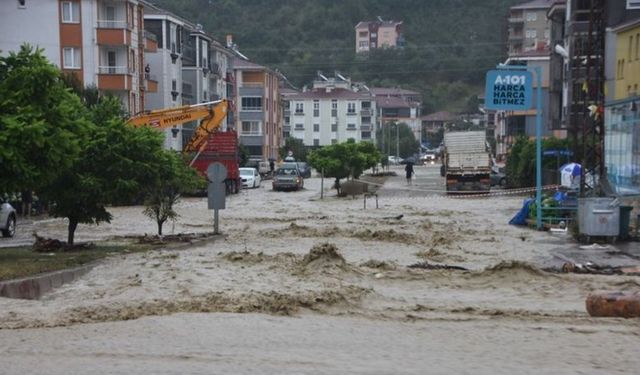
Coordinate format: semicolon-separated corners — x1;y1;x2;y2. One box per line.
127;99;229;152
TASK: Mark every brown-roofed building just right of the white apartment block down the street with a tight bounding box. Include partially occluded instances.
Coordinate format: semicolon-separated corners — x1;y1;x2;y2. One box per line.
370;87;423;143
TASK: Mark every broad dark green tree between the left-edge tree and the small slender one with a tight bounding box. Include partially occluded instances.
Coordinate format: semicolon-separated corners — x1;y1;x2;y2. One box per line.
43;98;164;245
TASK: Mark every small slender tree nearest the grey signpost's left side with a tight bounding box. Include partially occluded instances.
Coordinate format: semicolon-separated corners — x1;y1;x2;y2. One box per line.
143;150;202;236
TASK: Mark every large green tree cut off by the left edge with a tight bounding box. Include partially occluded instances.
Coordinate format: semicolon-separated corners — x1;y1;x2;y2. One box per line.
0;45;91;193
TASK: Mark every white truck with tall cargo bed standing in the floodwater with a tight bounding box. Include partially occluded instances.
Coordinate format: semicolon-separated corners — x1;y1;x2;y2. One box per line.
441;131;491;194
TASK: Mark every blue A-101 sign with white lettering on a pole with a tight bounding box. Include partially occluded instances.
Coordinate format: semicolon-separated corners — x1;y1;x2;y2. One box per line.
485;70;533;111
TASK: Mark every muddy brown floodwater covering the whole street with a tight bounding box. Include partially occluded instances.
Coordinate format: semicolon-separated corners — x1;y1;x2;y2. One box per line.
0;166;640;374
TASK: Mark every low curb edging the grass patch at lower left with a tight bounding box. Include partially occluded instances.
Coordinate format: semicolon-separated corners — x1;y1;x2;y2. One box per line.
0;264;95;299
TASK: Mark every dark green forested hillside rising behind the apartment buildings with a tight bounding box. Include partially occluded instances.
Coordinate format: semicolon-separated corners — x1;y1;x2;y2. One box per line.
153;0;521;114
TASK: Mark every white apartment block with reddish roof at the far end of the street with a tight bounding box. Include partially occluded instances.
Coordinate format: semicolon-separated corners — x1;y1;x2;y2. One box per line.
283;74;377;146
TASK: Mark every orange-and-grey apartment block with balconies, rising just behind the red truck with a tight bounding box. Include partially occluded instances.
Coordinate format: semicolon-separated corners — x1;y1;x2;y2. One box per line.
232;57;282;160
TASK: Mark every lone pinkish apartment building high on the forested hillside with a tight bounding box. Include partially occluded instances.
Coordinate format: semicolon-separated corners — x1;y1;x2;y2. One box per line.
355;17;404;53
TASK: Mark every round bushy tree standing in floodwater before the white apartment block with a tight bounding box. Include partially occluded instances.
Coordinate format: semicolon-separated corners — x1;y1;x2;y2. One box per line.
308;140;381;193
